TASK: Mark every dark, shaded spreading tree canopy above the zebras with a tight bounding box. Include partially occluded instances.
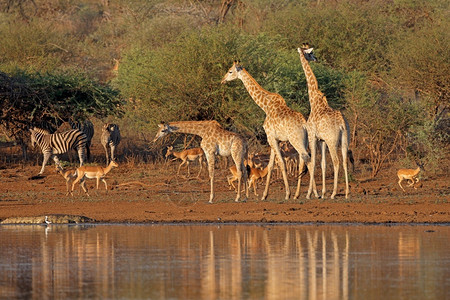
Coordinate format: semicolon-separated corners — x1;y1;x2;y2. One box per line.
0;72;122;145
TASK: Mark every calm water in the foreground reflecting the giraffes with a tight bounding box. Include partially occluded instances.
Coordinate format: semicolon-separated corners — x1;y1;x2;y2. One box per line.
0;225;450;300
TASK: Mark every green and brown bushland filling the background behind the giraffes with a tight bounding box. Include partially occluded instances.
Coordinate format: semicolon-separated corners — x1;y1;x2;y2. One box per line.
0;0;450;175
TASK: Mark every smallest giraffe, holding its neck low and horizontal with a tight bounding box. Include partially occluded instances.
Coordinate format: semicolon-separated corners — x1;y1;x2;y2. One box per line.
153;121;248;203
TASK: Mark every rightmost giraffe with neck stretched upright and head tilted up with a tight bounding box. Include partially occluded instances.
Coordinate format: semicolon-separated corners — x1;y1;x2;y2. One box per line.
297;44;353;199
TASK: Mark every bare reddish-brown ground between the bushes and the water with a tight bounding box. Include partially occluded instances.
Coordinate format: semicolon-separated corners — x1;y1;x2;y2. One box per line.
0;162;450;223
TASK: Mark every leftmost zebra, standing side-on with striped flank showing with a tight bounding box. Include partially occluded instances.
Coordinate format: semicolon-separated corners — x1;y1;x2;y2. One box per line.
30;127;87;175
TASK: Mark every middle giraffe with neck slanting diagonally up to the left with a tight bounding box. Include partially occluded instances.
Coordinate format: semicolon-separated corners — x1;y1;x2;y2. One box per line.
222;61;317;200
